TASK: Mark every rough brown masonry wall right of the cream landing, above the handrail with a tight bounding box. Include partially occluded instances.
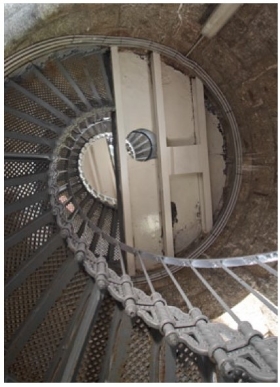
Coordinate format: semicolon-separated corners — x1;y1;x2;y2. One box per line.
192;4;277;256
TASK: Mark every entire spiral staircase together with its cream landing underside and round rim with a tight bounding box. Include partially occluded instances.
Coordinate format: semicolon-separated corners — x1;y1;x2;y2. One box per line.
5;36;278;382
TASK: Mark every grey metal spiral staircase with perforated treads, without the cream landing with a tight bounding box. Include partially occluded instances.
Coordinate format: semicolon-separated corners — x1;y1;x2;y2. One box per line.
4;37;278;382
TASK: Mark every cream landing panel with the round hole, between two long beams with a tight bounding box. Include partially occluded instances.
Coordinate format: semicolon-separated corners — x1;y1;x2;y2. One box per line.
119;52;162;266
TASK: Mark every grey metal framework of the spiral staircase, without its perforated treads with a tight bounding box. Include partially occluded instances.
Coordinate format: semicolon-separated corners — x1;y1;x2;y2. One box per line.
5;36;278;382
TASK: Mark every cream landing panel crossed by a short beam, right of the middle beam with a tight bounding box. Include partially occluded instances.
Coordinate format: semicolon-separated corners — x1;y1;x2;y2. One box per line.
162;63;209;253
